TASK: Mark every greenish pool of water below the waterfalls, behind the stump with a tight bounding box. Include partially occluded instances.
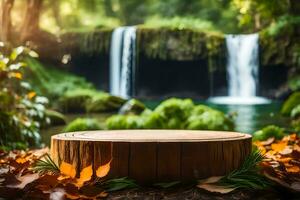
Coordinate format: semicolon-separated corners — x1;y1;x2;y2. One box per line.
41;100;288;145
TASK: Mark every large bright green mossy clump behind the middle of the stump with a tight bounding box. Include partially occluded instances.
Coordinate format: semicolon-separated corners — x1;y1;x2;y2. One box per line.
106;98;234;130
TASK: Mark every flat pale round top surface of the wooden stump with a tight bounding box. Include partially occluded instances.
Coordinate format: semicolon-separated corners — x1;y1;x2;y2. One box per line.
52;130;251;142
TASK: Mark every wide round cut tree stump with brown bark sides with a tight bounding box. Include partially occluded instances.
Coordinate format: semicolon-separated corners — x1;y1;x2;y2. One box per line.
51;130;251;184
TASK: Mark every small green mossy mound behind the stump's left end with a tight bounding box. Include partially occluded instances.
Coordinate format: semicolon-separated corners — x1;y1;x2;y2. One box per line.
64;118;102;132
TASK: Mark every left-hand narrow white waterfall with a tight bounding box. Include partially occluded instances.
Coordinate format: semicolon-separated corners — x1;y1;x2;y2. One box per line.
110;26;136;98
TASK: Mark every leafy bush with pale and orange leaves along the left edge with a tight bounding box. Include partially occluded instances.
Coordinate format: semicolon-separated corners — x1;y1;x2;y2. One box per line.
0;43;48;148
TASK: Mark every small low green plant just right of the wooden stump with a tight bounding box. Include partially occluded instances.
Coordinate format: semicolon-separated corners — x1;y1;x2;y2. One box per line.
253;125;285;141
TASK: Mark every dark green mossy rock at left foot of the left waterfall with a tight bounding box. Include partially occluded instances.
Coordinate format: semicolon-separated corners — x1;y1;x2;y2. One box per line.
86;93;125;113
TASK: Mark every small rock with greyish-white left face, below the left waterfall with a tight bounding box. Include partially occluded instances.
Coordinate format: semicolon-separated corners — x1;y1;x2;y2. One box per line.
119;99;146;115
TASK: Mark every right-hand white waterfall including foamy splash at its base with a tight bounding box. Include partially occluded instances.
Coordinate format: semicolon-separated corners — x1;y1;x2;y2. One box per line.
209;33;269;104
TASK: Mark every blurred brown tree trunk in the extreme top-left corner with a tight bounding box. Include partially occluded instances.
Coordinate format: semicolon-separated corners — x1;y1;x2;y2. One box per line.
0;0;14;42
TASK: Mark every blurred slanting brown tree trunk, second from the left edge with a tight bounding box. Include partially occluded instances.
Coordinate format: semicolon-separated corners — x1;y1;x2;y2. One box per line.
20;0;43;43
